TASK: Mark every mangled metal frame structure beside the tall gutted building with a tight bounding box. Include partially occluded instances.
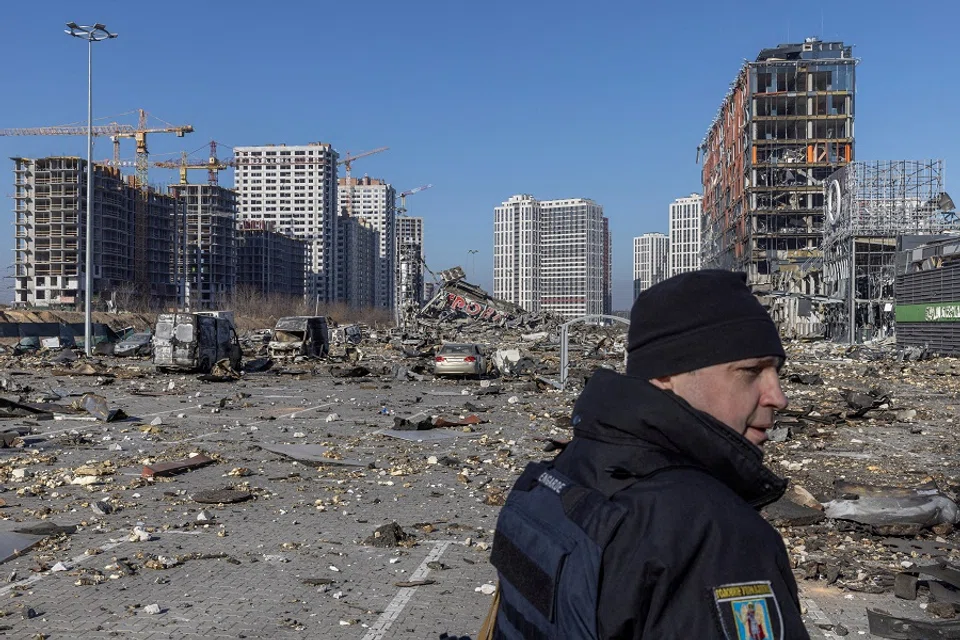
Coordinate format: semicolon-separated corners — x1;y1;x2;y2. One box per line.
822;160;960;343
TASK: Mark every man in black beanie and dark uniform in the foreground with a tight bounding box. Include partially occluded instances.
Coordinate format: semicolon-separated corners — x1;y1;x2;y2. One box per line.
491;270;809;640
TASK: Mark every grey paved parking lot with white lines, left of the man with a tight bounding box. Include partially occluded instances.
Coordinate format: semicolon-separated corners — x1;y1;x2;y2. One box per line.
0;362;880;640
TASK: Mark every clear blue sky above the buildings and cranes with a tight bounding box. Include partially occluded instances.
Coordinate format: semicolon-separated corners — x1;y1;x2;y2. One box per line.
0;0;960;308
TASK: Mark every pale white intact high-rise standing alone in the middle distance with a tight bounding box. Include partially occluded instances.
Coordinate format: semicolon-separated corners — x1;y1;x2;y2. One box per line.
493;195;610;318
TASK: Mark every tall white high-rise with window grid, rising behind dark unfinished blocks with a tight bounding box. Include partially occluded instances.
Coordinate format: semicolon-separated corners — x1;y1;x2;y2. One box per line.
234;142;338;302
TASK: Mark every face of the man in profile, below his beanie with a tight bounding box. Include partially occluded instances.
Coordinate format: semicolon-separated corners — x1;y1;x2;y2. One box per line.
651;356;787;447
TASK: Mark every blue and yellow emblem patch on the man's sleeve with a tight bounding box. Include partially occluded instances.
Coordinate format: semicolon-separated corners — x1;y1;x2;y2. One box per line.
711;582;783;640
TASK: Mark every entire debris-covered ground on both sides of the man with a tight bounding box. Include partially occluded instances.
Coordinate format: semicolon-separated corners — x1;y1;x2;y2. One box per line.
0;308;960;639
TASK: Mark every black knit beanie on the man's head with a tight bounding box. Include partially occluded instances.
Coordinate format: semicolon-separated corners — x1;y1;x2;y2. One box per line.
627;270;786;380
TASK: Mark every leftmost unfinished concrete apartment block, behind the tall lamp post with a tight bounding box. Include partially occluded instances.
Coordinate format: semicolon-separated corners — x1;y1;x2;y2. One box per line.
13;156;176;308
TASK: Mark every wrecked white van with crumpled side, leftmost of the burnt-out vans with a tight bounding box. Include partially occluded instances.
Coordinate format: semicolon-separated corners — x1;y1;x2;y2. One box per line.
153;311;241;373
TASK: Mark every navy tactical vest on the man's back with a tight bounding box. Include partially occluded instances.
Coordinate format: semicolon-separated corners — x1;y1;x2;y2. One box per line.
490;462;633;640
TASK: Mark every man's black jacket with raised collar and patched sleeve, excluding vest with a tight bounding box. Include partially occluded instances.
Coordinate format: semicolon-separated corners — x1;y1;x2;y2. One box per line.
555;370;809;640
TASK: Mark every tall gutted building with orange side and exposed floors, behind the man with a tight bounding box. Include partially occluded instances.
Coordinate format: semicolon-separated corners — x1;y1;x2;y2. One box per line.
698;38;857;294
